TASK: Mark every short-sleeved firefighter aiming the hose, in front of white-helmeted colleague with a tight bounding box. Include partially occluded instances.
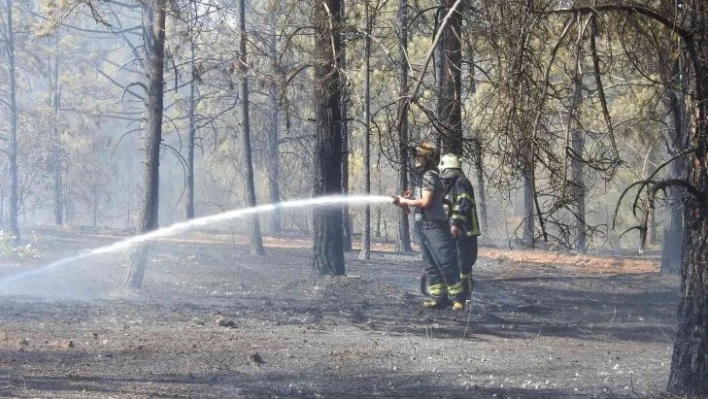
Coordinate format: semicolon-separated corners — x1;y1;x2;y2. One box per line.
394;142;465;310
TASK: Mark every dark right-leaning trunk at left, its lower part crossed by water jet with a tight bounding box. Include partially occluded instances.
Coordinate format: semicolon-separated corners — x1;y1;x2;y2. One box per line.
123;0;167;288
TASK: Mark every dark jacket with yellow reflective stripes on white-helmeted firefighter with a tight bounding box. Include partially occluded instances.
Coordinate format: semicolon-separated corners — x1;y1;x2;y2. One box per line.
440;169;482;237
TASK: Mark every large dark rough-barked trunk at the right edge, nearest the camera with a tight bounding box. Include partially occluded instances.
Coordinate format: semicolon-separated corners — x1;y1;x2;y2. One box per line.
668;4;708;397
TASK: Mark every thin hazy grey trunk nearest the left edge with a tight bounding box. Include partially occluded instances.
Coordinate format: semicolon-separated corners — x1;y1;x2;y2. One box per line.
5;0;20;243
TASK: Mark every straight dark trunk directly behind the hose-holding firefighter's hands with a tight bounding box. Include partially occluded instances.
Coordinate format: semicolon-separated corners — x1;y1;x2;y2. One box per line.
396;0;413;253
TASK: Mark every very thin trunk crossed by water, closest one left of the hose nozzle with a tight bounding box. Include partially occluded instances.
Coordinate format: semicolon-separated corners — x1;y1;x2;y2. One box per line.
359;0;371;260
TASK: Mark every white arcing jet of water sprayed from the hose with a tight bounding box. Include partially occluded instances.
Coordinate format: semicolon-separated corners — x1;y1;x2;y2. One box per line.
0;195;393;295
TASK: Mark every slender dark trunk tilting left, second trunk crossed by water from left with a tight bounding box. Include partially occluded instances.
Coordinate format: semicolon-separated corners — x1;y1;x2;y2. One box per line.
239;0;265;255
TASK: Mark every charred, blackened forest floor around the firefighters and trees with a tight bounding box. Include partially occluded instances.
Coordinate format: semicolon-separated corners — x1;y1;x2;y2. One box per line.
0;228;679;399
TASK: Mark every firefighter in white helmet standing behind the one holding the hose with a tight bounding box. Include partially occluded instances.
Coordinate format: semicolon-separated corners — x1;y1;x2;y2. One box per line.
438;154;481;299
